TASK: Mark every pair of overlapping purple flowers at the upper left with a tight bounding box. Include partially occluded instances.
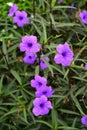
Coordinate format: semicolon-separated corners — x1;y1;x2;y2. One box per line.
8;4;29;27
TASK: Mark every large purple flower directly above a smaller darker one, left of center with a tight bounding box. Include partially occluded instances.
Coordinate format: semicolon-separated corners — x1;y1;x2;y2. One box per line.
19;35;41;53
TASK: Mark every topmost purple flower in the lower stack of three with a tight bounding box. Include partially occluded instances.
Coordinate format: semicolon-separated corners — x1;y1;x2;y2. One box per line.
31;75;47;90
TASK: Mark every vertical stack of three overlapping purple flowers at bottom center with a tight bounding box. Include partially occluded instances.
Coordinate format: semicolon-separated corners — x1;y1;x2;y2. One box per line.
31;75;53;116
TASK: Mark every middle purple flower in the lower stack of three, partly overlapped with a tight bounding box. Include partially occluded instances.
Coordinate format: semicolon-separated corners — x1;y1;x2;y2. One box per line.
35;86;53;97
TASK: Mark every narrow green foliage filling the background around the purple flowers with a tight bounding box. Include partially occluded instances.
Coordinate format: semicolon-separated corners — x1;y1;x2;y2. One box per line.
0;0;87;130
